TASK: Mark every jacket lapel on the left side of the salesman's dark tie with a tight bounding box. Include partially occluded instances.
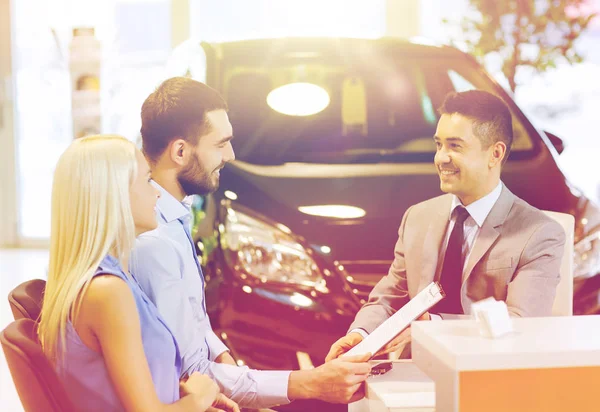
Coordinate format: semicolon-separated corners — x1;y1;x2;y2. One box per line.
419;196;452;291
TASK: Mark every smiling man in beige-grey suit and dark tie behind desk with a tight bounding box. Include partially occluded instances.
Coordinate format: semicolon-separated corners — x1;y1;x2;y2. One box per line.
326;90;565;360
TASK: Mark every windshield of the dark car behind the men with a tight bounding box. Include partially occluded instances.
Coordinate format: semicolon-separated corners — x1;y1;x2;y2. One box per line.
210;43;534;165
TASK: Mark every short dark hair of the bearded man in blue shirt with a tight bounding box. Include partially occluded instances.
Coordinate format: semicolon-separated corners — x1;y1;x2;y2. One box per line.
141;77;227;162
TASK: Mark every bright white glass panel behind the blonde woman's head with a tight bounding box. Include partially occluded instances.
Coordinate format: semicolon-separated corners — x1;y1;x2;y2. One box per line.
13;0;170;239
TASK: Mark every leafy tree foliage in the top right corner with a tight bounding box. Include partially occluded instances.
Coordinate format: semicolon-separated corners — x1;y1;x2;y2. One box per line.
452;0;596;92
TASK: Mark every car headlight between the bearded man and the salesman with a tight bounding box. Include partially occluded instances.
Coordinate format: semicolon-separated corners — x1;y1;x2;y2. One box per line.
220;208;325;288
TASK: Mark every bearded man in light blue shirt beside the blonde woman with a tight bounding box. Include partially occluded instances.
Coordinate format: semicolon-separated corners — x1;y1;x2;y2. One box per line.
130;77;370;408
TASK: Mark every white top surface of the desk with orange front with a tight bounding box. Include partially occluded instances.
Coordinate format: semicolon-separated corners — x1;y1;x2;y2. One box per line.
412;315;600;371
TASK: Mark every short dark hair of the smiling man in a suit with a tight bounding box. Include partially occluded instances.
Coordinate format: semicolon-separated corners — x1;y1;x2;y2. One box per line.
439;90;513;163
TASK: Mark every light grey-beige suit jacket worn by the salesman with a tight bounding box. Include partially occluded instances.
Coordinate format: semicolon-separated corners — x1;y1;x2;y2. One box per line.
350;187;565;333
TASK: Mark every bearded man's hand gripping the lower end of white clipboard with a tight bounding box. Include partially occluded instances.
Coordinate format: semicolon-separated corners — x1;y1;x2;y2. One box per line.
288;353;371;403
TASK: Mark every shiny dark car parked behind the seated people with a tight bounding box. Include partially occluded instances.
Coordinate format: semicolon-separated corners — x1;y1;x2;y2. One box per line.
190;38;600;369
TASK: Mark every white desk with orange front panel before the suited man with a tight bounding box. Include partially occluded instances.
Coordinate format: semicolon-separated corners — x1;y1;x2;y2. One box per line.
349;316;600;412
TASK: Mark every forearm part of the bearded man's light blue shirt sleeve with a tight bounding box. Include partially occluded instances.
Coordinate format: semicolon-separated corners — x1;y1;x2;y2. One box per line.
205;362;291;408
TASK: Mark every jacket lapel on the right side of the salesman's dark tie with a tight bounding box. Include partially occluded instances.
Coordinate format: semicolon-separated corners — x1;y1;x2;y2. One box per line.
463;185;515;284
